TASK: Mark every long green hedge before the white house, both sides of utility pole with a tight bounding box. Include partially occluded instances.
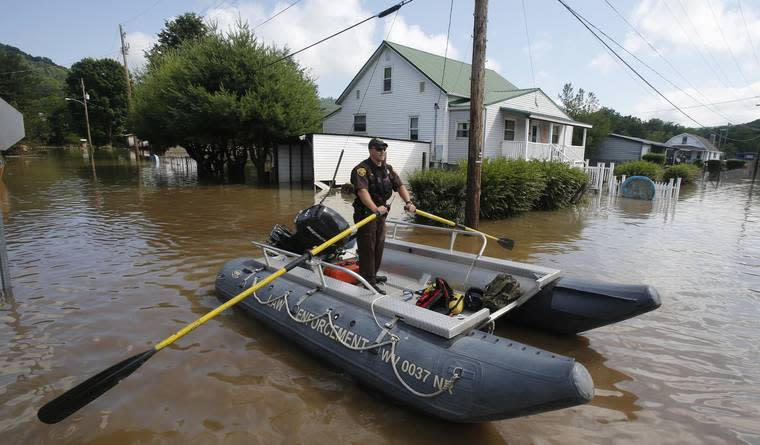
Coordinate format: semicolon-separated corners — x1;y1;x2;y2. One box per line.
407;158;586;220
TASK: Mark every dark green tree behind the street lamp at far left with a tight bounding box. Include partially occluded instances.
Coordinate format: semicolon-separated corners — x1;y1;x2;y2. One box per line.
66;58;127;145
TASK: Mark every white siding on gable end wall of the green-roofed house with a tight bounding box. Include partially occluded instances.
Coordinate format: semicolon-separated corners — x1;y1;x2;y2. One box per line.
322;46;448;161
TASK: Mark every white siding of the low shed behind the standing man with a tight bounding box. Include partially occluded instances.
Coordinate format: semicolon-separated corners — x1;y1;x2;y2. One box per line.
312;134;430;185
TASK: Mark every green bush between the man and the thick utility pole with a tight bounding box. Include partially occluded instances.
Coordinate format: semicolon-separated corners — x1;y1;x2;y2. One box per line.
407;169;467;221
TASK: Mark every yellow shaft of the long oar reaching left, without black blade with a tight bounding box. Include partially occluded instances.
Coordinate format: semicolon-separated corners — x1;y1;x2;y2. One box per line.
155;214;377;351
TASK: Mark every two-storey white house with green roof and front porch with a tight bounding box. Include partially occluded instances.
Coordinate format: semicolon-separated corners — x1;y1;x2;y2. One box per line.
323;41;591;164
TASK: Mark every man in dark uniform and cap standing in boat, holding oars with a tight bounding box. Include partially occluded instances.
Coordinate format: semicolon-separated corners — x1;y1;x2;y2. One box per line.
351;138;416;295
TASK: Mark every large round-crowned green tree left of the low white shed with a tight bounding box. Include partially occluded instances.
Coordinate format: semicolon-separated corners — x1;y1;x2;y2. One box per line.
131;24;321;181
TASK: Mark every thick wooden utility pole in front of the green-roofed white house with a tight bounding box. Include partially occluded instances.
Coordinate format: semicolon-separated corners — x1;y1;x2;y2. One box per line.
464;0;488;229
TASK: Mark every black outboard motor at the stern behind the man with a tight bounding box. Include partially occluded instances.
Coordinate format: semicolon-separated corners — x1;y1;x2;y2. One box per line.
269;204;354;257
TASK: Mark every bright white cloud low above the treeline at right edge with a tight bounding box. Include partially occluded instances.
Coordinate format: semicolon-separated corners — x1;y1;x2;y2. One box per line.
634;81;760;127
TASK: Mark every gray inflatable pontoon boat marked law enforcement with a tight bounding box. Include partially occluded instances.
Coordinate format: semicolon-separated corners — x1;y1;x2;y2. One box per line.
216;220;660;422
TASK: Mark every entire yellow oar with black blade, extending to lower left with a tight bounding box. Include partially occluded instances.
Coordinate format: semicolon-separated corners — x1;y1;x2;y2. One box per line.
37;214;376;423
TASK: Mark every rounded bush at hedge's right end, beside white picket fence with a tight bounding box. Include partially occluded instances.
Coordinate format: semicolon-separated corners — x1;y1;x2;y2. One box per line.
535;162;588;210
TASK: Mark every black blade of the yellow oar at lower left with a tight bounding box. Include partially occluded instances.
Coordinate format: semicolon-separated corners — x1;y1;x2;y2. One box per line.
37;348;157;424
